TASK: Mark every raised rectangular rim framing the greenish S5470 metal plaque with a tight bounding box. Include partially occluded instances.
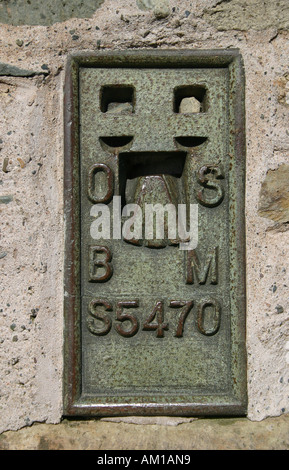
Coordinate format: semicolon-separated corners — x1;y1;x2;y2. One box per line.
63;49;247;417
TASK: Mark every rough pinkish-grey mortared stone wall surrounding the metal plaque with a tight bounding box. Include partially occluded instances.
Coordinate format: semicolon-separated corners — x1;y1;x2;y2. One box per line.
0;0;289;432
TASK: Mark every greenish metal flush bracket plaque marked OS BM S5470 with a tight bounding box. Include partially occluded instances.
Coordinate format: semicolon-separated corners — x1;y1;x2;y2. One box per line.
64;50;247;416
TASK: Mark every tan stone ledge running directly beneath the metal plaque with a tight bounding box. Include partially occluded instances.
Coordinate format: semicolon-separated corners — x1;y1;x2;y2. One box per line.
0;415;289;455
